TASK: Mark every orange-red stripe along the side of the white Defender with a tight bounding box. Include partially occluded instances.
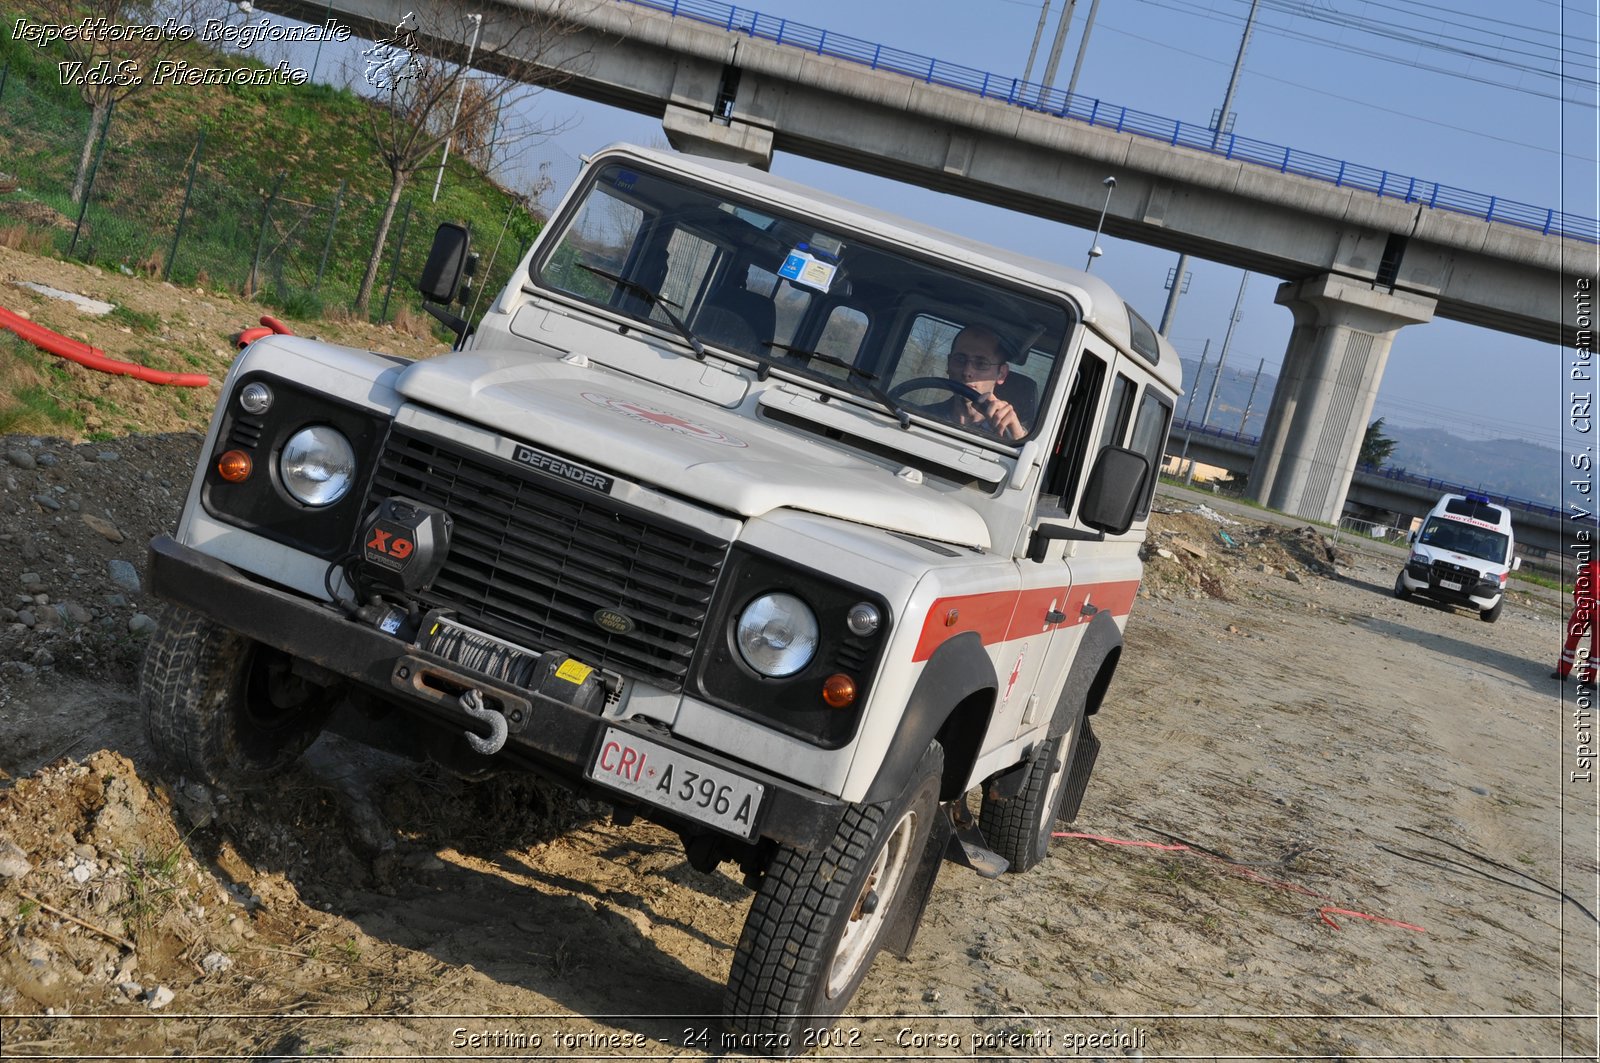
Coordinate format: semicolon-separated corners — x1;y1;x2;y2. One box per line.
910;580;1139;661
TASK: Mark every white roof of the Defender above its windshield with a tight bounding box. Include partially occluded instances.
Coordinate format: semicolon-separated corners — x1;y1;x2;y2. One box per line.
590;144;1182;392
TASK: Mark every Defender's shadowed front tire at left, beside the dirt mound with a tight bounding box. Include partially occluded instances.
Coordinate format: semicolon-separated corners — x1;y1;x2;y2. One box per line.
139;607;338;784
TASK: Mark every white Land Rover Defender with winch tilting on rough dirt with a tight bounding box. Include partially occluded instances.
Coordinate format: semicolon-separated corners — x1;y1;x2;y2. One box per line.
141;147;1181;1053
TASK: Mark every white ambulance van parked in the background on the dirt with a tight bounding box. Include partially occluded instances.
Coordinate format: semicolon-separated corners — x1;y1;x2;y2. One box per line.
1395;495;1522;624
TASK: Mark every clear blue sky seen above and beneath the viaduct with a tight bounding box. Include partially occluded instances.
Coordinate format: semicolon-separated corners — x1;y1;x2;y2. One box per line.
249;0;1600;477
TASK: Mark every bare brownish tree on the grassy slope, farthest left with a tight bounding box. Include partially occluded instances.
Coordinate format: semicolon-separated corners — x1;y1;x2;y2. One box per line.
32;0;222;203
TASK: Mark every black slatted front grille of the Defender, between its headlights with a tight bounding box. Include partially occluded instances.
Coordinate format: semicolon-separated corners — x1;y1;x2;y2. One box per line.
366;426;728;690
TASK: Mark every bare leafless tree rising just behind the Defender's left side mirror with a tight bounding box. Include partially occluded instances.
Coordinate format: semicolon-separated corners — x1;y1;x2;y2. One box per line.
355;5;571;314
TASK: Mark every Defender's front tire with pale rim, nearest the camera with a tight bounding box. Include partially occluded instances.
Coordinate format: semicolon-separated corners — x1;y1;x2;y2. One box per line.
723;743;944;1055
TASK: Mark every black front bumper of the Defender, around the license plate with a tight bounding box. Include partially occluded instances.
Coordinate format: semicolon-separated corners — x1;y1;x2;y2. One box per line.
149;535;846;850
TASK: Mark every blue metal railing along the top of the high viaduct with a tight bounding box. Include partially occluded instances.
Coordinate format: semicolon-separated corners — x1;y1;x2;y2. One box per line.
618;0;1600;243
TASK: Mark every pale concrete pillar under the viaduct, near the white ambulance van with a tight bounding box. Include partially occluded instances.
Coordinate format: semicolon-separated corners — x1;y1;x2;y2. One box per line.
1250;274;1437;522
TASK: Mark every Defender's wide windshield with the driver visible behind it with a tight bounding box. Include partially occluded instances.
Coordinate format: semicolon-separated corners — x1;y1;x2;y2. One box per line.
533;163;1072;442
